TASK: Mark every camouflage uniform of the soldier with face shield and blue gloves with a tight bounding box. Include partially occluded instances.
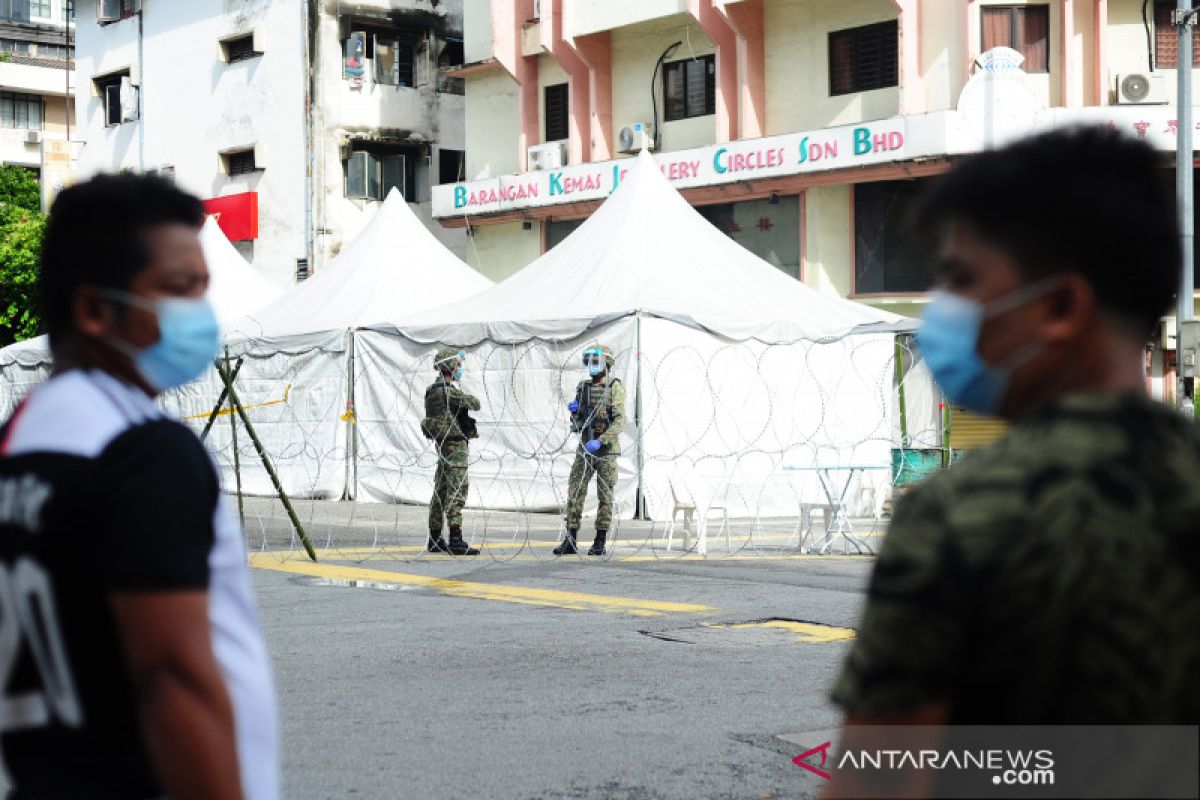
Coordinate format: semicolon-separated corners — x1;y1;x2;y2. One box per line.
556;345;625;549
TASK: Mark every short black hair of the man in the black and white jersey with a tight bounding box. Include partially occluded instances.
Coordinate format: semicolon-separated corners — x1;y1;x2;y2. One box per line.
38;174;204;349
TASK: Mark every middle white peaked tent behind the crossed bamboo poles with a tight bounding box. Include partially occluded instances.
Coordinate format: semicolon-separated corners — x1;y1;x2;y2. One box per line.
177;190;492;498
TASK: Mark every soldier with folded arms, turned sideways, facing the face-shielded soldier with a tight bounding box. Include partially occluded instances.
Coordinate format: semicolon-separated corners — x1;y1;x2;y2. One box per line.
421;348;480;555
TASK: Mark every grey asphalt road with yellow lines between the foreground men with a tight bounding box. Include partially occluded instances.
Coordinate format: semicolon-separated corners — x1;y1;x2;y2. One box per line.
251;496;871;800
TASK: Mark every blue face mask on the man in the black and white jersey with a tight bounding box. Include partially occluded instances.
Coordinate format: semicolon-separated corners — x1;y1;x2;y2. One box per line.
104;291;221;392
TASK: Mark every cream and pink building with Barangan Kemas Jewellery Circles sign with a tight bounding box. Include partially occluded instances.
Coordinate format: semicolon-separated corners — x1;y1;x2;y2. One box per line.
434;0;1200;345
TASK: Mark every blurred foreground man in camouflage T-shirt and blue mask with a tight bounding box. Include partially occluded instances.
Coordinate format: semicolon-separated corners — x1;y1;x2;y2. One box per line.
830;128;1200;796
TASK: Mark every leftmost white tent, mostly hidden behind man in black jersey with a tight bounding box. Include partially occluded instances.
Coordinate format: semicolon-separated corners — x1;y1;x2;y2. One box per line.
0;217;283;415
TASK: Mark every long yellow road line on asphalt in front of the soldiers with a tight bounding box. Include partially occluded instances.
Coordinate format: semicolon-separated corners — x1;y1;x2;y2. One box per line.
250;553;716;616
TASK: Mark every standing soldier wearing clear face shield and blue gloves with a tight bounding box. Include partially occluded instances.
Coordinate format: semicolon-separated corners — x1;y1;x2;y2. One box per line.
554;344;625;555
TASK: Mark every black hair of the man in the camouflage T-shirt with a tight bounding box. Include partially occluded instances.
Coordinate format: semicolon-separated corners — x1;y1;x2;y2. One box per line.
920;126;1182;336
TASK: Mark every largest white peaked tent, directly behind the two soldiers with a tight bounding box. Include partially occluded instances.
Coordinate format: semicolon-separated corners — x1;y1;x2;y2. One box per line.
355;154;931;532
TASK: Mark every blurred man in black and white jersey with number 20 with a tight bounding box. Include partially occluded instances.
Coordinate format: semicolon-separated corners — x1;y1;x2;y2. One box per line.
0;175;277;799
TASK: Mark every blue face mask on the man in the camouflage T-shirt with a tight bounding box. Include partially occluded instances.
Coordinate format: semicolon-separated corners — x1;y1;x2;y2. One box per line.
917;281;1054;414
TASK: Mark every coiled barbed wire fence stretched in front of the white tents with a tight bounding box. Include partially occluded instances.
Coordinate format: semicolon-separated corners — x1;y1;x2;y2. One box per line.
0;320;944;560
